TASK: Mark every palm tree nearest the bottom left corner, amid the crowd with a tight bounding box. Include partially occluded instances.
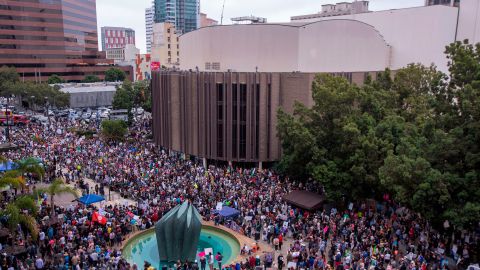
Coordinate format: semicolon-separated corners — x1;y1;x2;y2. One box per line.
0;196;38;240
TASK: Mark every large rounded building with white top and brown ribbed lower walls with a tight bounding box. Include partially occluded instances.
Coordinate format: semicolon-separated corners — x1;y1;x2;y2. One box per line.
152;0;480;165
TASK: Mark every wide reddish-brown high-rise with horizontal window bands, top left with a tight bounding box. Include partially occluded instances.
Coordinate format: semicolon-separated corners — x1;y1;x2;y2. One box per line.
0;0;131;82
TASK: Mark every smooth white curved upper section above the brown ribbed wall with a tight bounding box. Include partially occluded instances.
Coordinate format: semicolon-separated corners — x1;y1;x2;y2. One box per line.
180;0;480;73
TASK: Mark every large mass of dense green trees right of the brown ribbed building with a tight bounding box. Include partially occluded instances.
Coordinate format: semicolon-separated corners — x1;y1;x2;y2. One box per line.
277;42;480;228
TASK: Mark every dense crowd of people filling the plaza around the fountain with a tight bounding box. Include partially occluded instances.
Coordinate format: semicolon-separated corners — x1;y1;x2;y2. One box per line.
0;115;479;270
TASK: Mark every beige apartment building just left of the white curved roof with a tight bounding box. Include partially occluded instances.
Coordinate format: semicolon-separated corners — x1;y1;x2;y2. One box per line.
151;22;180;68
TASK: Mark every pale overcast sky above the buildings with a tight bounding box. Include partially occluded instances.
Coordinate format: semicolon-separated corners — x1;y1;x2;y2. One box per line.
97;0;425;53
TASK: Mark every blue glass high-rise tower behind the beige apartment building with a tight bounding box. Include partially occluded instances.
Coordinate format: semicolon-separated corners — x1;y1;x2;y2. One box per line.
154;0;200;34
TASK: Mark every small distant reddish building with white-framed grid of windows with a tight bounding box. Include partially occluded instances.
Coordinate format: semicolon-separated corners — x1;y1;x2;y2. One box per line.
102;26;135;51
